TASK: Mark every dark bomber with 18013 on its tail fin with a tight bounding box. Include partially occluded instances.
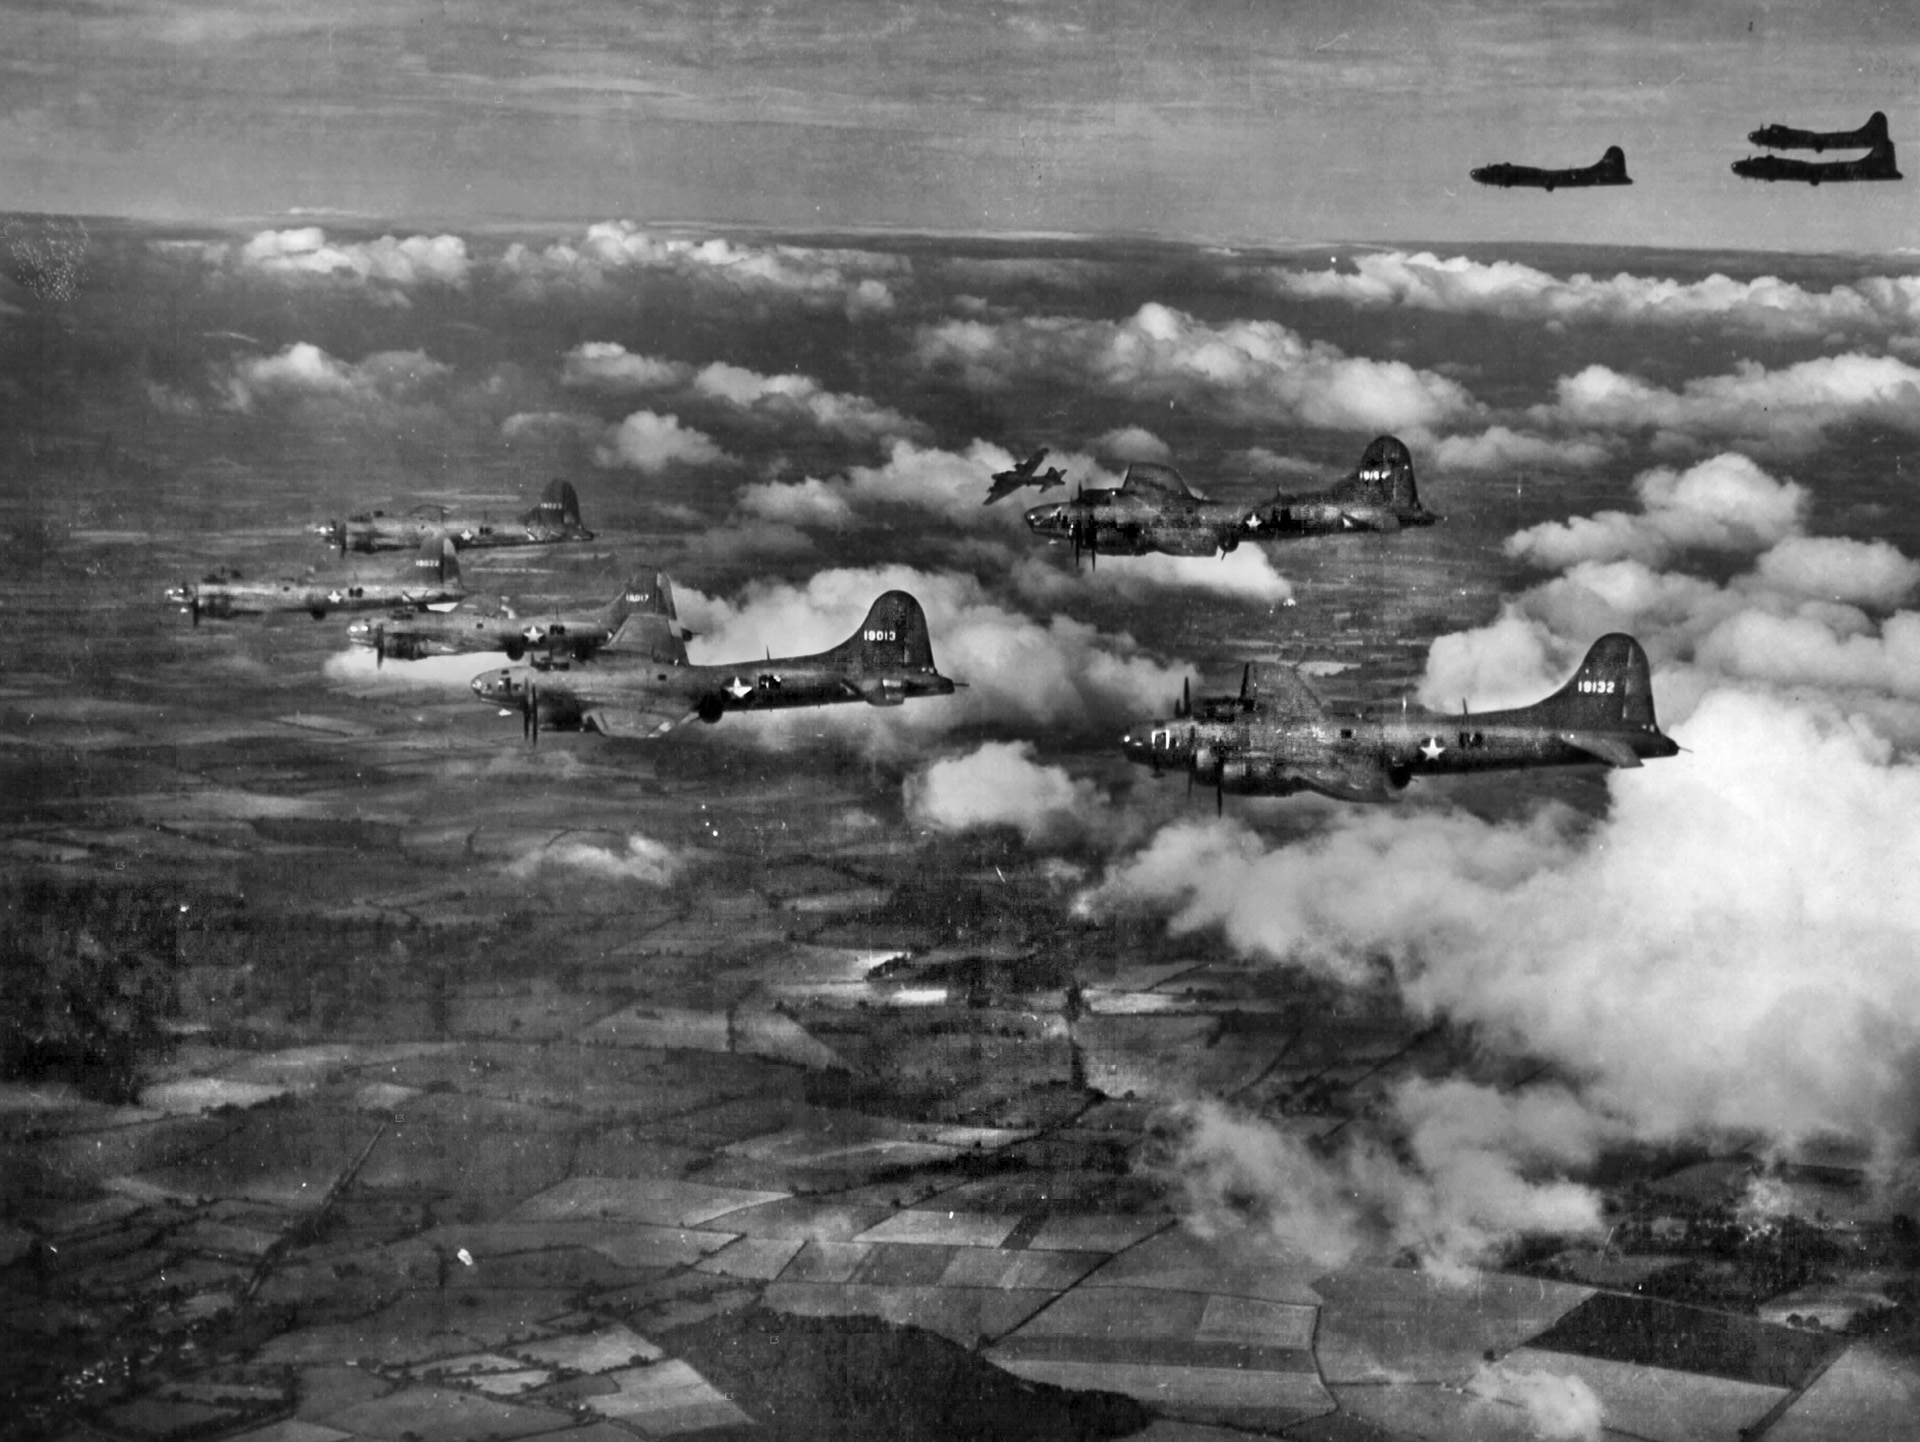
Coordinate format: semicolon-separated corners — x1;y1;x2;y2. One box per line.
472;591;958;743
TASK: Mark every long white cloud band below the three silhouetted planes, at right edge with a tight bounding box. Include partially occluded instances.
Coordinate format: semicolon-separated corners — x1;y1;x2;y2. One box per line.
1273;252;1920;338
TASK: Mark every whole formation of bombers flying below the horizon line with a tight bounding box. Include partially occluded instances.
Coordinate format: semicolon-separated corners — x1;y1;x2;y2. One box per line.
167;436;1678;805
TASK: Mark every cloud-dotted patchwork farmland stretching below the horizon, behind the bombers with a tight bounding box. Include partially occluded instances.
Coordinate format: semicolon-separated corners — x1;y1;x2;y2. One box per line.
0;217;1920;1442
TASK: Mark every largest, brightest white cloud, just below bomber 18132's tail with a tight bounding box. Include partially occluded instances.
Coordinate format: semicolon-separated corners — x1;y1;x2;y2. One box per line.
1087;710;1920;1152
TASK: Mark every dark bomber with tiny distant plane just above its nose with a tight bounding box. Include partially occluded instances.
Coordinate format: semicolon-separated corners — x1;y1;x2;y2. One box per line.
1027;436;1438;563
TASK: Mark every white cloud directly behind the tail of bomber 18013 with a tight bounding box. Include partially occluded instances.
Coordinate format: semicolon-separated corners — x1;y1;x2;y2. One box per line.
676;566;1187;749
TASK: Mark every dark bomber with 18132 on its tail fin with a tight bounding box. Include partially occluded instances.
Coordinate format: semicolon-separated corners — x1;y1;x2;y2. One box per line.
1121;632;1680;805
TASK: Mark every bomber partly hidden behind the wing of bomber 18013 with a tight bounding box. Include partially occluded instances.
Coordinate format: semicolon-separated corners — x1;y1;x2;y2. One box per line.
348;574;687;664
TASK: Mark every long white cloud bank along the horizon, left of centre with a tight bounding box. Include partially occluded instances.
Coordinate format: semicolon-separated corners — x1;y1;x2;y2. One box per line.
499;221;912;321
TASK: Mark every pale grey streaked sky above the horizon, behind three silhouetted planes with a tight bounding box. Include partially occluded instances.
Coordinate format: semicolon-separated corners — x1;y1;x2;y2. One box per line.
11;0;1920;252
